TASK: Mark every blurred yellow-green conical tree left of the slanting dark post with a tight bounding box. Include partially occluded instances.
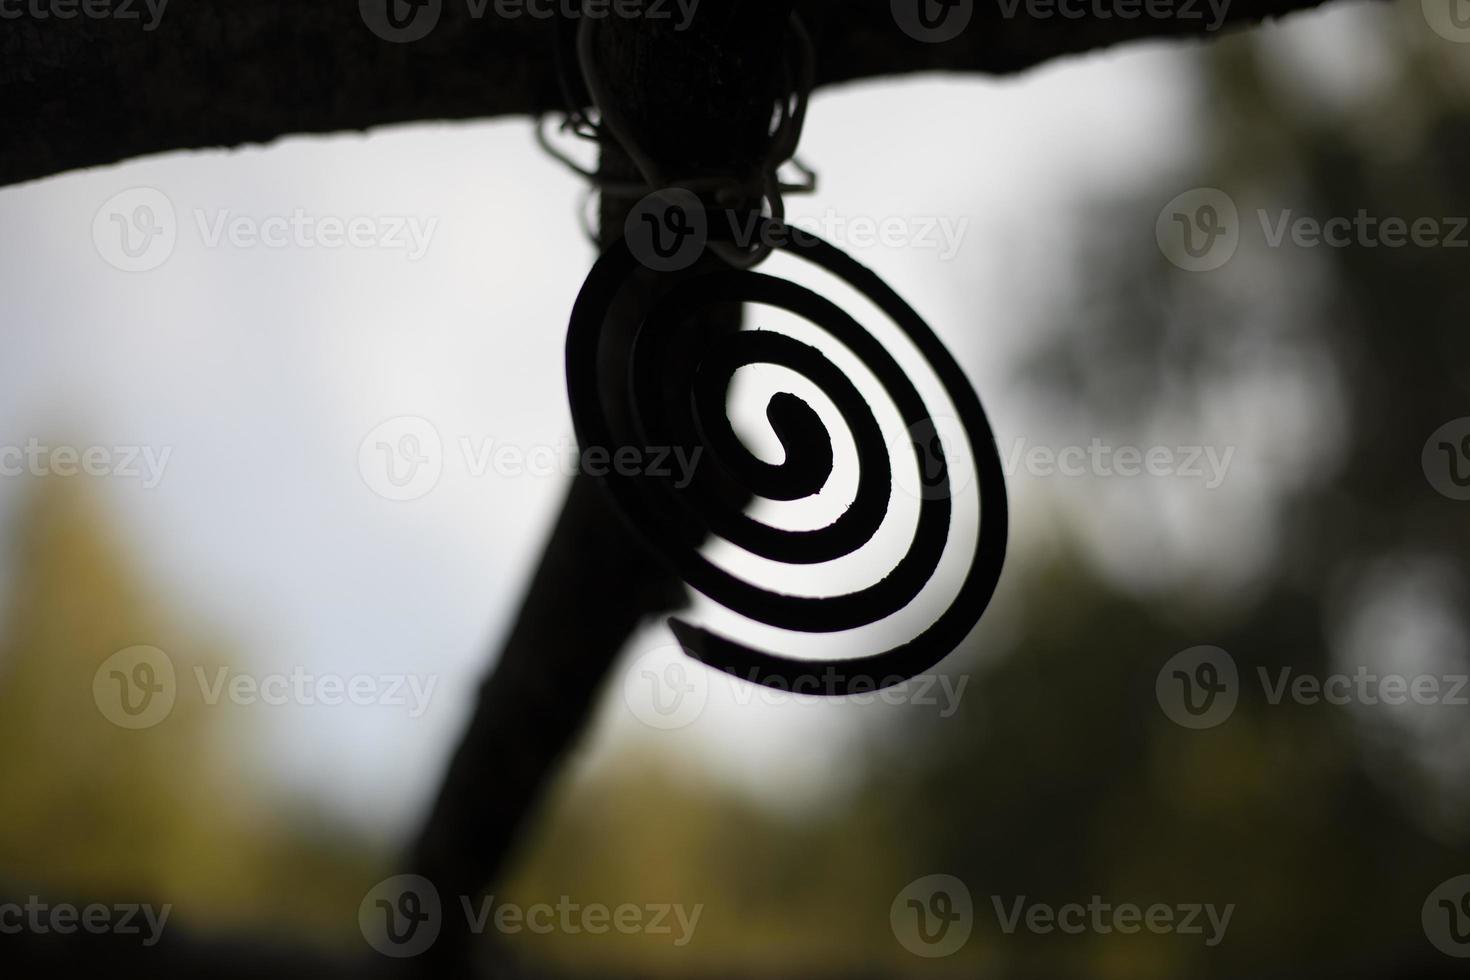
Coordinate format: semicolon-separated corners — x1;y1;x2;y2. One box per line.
0;479;376;940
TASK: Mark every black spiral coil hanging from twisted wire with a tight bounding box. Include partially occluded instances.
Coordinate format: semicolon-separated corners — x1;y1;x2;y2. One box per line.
566;219;1007;695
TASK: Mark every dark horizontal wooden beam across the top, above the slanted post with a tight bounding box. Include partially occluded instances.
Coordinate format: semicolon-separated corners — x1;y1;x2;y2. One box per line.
0;0;1364;185
